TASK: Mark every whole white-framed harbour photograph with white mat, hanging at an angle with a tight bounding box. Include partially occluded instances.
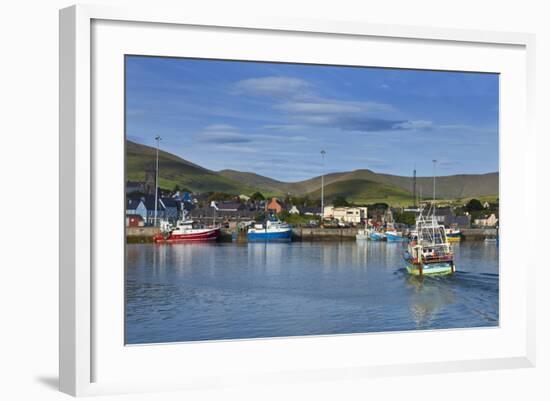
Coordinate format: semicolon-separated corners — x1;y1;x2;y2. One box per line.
60;6;536;395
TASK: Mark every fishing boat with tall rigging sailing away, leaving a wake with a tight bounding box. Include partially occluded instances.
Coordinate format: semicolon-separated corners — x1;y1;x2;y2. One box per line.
404;206;456;276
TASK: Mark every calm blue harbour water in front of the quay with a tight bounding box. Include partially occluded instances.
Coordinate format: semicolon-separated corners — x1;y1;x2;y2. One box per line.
126;241;499;344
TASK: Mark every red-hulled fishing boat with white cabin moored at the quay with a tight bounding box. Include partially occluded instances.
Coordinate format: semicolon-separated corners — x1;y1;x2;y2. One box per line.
153;215;220;244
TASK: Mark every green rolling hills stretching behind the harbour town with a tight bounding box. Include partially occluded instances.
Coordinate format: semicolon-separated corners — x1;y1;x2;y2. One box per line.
126;141;499;204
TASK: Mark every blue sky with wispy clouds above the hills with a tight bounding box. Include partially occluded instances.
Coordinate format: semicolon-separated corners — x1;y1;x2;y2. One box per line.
126;56;499;181
